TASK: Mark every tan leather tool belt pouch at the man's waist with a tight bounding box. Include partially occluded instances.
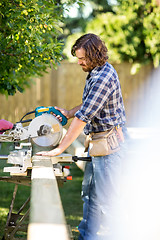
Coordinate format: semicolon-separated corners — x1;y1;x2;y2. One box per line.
89;128;120;157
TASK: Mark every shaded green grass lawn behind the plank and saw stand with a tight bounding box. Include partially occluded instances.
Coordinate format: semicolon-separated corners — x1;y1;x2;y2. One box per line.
0;143;83;240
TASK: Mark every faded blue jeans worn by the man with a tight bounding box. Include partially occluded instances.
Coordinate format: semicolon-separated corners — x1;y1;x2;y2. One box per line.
78;131;126;240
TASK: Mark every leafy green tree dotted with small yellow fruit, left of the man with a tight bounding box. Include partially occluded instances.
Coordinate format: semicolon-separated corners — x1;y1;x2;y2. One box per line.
0;0;81;95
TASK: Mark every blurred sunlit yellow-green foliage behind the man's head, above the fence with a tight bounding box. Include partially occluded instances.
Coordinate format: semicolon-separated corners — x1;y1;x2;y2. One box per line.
65;0;160;73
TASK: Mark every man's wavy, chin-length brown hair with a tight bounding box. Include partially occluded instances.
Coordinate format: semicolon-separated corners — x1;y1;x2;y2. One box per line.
71;33;108;67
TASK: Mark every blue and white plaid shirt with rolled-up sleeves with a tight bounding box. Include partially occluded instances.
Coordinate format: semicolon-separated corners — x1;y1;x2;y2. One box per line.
75;62;126;134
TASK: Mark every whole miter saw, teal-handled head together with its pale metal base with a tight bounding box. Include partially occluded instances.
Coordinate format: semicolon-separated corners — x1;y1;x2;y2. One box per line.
0;106;71;175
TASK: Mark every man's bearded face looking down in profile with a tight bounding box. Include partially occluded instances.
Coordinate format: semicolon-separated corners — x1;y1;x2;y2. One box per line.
75;48;92;72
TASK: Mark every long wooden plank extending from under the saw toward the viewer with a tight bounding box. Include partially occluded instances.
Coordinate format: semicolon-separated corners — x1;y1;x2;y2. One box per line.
27;156;69;240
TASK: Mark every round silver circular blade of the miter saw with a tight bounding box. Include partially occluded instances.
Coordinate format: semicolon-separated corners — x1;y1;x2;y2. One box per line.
28;113;63;147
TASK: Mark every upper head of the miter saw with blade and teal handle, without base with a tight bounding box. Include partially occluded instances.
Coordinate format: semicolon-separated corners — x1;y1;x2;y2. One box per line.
0;106;67;147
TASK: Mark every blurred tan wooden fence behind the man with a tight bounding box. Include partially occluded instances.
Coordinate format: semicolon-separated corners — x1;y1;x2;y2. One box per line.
0;62;153;126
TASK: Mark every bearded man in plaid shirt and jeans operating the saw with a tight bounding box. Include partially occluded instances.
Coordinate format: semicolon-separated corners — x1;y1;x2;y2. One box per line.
38;34;126;240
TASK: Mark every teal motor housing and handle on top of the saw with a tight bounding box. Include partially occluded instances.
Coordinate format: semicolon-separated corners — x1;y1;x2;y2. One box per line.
35;106;67;126
